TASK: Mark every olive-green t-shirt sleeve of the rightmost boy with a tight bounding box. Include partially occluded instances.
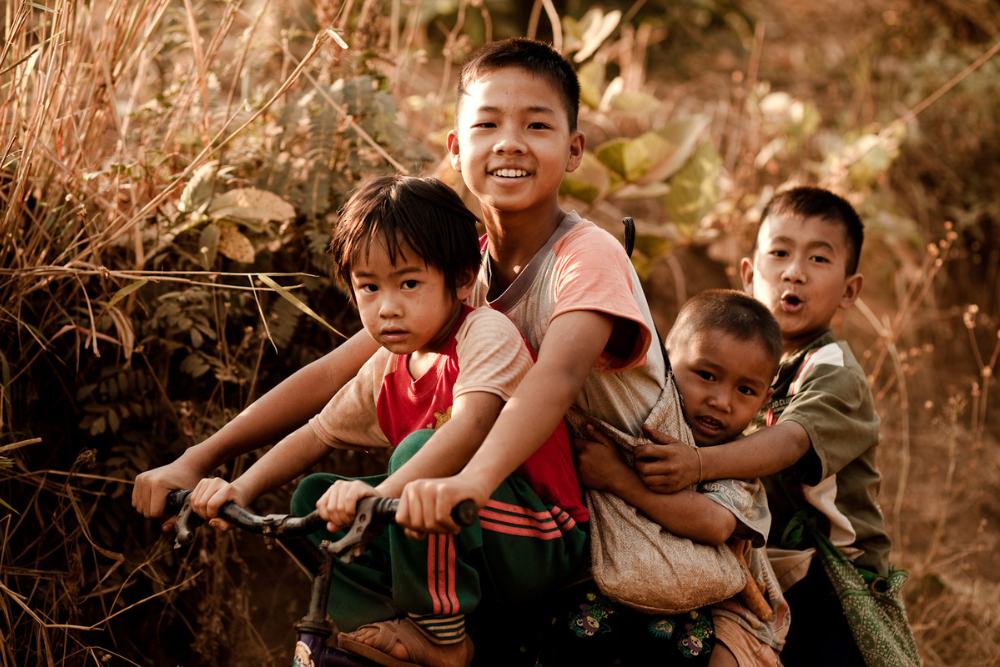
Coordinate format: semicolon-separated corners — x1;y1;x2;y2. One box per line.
778;364;879;486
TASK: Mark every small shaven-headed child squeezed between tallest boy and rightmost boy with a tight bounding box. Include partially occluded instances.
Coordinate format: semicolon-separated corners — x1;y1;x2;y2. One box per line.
576;290;789;667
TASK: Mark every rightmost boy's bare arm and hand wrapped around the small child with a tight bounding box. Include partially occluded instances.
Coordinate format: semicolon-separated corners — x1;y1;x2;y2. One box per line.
635;421;812;493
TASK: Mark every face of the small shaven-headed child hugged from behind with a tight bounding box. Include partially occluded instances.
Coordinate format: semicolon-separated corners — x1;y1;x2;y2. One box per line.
669;331;775;446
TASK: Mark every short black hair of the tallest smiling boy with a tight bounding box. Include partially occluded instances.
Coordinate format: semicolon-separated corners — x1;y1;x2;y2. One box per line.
456;37;580;132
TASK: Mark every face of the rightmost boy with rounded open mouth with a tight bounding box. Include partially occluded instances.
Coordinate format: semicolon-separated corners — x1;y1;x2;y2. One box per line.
740;214;863;352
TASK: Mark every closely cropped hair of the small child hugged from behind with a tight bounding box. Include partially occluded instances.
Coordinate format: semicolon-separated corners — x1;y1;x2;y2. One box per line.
667;289;782;371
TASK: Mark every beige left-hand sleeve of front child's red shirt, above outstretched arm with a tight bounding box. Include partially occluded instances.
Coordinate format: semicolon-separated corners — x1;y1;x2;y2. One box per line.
309;348;393;449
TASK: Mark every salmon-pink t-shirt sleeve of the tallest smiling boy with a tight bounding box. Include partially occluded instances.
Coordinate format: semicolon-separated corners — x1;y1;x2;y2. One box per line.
550;227;652;370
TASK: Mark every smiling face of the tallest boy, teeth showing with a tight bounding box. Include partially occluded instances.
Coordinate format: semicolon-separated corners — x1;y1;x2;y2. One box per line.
448;67;584;224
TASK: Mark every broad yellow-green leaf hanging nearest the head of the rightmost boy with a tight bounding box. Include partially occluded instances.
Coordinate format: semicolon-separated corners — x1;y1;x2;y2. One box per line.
664;142;722;239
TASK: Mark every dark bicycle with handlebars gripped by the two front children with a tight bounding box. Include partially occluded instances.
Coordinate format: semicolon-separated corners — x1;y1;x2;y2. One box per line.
167;490;478;667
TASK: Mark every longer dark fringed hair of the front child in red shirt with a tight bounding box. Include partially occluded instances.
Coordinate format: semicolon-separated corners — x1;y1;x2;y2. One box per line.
330;176;481;299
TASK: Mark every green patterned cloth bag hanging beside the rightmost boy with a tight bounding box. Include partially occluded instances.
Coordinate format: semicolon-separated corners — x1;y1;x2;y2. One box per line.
812;524;920;667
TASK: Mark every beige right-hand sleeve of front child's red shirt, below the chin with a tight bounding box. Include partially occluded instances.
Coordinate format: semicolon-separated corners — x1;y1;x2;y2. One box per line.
452;308;533;401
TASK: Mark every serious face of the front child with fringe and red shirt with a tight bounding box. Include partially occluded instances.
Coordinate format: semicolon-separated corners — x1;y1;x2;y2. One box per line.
351;240;470;355
